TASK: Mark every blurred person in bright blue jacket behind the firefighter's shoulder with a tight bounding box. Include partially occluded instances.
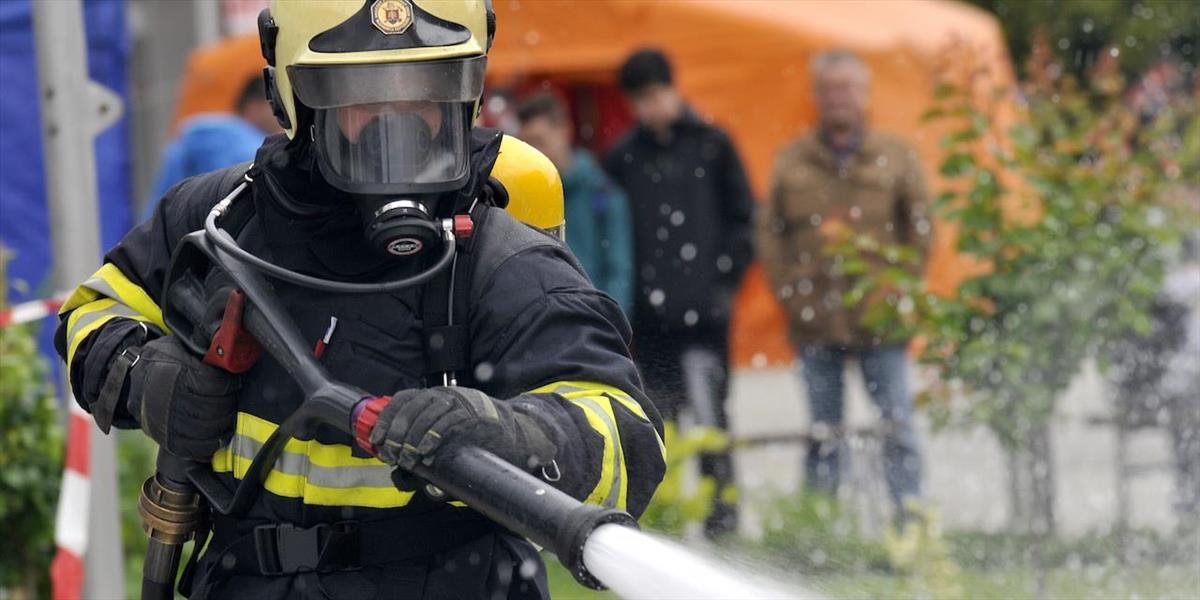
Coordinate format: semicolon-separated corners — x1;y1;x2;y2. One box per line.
142;77;283;221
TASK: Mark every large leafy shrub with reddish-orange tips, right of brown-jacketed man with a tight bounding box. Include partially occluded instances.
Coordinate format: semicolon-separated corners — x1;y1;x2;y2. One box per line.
828;45;1200;446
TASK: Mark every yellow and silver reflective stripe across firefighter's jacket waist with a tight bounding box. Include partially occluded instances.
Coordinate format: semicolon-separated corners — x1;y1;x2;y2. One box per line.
212;413;413;509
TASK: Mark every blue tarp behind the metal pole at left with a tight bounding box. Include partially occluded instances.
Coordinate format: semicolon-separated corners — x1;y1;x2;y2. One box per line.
0;0;132;364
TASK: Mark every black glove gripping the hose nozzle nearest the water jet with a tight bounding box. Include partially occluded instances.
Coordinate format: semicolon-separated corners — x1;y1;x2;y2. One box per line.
371;388;558;487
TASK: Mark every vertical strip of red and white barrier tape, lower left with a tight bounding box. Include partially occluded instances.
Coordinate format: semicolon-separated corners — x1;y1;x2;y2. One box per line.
50;402;95;600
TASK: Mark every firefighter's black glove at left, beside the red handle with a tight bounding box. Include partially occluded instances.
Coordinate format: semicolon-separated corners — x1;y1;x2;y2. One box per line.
127;336;241;461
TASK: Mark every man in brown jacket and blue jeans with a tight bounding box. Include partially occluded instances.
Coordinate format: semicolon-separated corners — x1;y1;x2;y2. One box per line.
757;50;930;509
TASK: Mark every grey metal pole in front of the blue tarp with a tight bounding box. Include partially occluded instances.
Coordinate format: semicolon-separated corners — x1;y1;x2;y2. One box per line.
32;0;125;598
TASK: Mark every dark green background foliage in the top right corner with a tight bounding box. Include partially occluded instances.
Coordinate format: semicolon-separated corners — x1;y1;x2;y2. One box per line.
968;0;1200;76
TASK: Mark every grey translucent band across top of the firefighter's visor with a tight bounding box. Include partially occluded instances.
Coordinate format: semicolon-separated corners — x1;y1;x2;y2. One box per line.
288;56;487;108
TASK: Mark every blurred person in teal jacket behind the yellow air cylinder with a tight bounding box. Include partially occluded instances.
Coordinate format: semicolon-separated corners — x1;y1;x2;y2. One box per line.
517;92;634;314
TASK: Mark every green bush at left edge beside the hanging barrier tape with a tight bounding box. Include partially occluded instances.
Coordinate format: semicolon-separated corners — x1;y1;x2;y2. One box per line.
0;250;62;598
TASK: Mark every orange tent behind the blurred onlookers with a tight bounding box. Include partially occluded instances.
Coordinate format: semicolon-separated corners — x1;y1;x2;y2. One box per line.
176;0;1013;366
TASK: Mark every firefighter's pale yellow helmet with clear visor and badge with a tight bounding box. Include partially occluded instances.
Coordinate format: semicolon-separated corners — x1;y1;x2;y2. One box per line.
258;0;496;194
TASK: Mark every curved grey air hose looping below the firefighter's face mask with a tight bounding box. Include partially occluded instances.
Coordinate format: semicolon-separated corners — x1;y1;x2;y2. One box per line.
204;174;474;294
